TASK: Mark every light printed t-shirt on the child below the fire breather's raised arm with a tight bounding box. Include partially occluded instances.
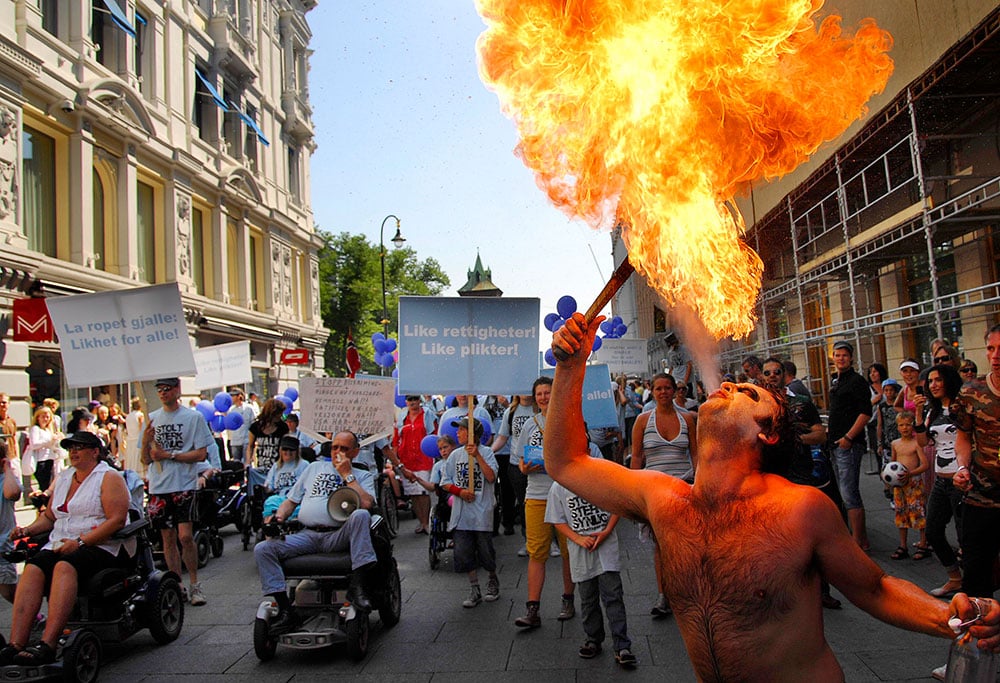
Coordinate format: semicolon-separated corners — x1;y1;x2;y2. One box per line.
545;483;621;583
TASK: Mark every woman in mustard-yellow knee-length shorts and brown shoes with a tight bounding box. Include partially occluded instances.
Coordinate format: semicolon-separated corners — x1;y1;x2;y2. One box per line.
514;376;576;628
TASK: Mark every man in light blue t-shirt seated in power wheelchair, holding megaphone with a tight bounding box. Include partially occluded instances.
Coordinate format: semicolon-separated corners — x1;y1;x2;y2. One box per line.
254;432;376;635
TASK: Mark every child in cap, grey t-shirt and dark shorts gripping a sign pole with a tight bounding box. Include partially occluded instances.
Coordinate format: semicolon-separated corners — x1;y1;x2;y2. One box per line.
441;418;500;607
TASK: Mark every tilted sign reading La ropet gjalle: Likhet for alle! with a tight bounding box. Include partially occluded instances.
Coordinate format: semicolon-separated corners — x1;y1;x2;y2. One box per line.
45;282;197;388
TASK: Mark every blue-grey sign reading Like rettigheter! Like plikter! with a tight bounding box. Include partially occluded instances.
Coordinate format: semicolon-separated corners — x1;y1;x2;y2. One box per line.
399;296;540;395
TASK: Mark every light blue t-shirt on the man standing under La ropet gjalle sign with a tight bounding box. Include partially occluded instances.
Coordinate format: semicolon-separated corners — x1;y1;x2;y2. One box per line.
146;406;215;495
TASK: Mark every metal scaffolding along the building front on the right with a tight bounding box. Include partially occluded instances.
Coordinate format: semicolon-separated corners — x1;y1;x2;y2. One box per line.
720;9;1000;406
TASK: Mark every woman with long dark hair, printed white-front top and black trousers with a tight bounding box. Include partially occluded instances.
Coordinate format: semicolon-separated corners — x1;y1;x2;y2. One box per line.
914;363;971;597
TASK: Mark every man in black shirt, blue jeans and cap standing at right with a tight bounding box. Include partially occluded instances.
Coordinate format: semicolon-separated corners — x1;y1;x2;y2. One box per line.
828;341;872;550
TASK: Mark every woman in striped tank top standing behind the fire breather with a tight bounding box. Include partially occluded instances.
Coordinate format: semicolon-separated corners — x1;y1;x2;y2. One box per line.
631;373;698;617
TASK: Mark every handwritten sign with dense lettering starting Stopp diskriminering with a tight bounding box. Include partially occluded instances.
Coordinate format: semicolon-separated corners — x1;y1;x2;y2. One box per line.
299;377;396;434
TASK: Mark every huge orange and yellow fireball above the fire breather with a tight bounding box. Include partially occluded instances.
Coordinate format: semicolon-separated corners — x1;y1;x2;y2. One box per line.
477;0;892;338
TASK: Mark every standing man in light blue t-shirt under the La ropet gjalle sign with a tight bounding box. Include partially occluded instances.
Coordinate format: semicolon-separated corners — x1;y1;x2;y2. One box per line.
142;377;215;606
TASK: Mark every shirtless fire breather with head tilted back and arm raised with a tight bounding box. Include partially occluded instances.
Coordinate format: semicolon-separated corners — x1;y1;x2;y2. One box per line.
545;313;1000;681
